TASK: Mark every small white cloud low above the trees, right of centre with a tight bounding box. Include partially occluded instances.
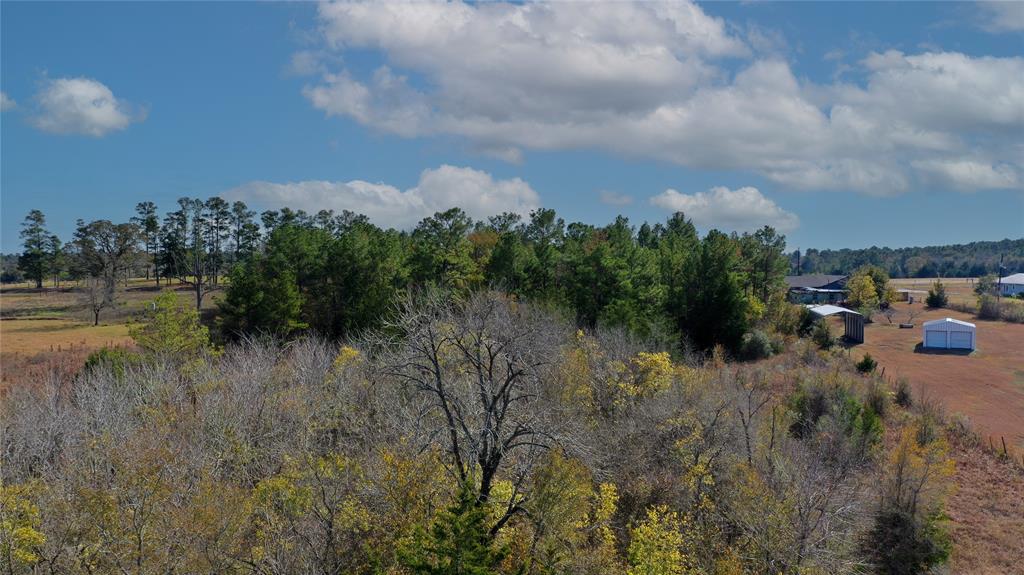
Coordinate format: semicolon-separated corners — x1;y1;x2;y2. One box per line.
650;186;800;231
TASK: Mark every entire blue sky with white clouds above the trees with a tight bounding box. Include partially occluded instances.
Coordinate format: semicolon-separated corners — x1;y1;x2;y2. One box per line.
0;2;1024;252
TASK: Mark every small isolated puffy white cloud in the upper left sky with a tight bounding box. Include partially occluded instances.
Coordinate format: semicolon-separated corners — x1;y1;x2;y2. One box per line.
32;78;143;137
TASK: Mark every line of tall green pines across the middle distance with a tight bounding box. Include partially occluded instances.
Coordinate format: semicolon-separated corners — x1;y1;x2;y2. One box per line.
19;197;787;351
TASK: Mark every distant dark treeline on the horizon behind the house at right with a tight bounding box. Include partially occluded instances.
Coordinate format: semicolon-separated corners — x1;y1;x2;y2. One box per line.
791;238;1024;277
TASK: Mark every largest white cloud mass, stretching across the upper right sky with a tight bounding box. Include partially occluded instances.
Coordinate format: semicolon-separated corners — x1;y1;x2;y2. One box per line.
304;1;1024;195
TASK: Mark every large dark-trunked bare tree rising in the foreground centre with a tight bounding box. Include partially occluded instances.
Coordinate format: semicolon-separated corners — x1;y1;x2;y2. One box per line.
376;293;565;533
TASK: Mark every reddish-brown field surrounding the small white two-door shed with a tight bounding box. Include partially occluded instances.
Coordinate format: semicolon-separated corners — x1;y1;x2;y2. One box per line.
851;302;1024;452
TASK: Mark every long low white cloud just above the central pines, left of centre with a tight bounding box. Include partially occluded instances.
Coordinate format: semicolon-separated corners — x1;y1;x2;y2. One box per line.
225;165;541;229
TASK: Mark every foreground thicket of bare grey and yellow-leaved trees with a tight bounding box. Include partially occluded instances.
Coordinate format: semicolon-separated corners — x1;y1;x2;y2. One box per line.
0;291;952;575
